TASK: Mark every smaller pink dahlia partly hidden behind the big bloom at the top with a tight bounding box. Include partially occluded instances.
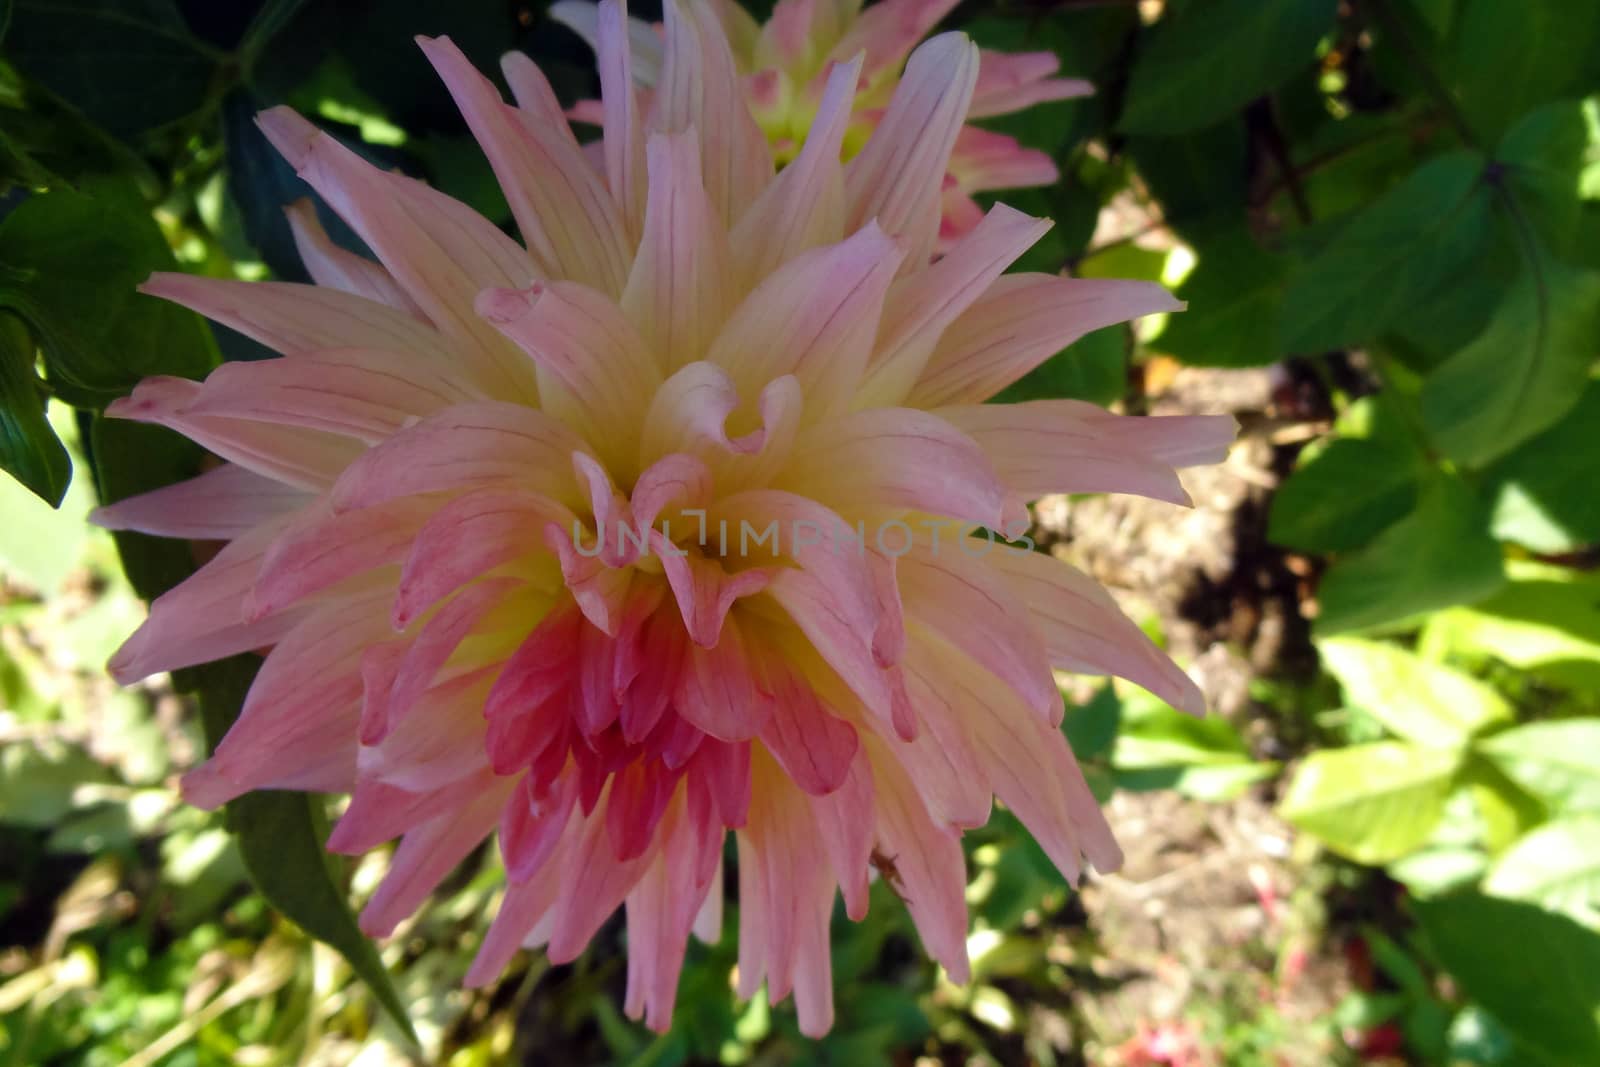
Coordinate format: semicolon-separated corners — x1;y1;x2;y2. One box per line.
550;0;1093;251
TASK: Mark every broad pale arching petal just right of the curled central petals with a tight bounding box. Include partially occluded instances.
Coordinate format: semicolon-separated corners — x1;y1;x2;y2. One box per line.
778;408;1006;531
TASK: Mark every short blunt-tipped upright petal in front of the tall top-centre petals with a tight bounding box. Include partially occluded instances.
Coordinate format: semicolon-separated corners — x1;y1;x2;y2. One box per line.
621;131;733;370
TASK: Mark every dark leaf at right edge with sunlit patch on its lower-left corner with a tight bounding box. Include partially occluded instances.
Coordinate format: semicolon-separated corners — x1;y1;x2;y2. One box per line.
1485;382;1600;553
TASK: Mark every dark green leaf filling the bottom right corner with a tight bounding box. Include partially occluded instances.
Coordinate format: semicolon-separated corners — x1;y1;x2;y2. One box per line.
1414;893;1600;1067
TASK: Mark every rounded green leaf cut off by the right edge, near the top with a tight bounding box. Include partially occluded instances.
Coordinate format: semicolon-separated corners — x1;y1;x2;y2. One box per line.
1494;101;1589;250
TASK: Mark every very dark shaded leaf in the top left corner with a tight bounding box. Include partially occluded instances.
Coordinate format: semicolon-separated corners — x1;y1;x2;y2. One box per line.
6;0;222;138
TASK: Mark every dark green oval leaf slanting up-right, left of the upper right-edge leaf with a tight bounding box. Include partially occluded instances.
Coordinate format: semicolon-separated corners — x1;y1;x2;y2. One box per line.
1283;152;1490;352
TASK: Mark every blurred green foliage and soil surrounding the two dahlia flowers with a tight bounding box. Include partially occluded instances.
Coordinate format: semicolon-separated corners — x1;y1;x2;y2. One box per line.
0;0;1600;1067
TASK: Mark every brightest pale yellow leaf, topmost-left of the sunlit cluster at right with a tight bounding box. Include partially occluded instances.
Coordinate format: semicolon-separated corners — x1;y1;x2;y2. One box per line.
1317;637;1512;747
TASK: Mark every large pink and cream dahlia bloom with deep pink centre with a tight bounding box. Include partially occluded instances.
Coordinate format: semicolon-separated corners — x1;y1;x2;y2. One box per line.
99;3;1232;1033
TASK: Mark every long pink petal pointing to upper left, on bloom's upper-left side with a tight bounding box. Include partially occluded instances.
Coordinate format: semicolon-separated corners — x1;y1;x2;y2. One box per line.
256;107;536;400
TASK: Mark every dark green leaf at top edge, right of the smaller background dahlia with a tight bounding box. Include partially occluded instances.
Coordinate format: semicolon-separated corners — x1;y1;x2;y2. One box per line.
1120;0;1338;133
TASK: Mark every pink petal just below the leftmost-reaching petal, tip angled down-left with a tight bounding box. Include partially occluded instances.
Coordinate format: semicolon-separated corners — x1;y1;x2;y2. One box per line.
106;518;299;685
